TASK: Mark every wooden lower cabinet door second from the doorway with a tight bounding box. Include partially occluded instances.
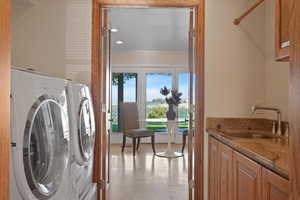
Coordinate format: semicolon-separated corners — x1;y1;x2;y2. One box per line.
219;143;233;200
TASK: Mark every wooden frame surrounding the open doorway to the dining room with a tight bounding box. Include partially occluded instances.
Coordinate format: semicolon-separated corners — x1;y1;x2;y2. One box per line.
91;0;205;200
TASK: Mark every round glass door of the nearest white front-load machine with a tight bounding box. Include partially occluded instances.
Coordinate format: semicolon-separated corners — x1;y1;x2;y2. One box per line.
23;96;69;199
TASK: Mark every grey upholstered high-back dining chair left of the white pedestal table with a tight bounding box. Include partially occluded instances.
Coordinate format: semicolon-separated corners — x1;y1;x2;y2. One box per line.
120;103;155;156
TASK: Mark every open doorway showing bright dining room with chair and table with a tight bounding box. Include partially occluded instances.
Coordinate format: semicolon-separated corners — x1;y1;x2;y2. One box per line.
102;8;195;200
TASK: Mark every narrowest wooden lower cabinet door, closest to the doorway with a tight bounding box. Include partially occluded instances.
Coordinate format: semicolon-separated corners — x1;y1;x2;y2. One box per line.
208;137;219;200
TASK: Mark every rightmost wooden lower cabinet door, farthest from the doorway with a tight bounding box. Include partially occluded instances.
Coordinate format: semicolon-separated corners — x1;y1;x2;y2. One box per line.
263;169;290;200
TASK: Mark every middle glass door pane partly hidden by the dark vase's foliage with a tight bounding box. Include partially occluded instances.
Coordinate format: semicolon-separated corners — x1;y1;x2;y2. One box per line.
146;73;172;132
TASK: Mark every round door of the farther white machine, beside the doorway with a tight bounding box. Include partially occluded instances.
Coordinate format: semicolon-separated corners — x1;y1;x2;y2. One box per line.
78;98;95;162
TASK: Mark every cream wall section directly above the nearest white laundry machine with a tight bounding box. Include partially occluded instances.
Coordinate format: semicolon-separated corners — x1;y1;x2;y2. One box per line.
12;0;66;77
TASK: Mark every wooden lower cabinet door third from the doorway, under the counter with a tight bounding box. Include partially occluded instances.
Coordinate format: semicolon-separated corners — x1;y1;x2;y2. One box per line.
233;152;262;200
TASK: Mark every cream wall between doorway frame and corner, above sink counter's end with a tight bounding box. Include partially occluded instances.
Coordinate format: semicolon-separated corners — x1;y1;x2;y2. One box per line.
205;0;265;117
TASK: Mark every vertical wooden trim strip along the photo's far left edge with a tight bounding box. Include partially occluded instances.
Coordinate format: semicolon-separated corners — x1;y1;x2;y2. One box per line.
0;0;11;200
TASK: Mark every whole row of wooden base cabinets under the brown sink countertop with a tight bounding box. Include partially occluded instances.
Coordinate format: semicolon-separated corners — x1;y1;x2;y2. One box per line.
208;137;290;200
